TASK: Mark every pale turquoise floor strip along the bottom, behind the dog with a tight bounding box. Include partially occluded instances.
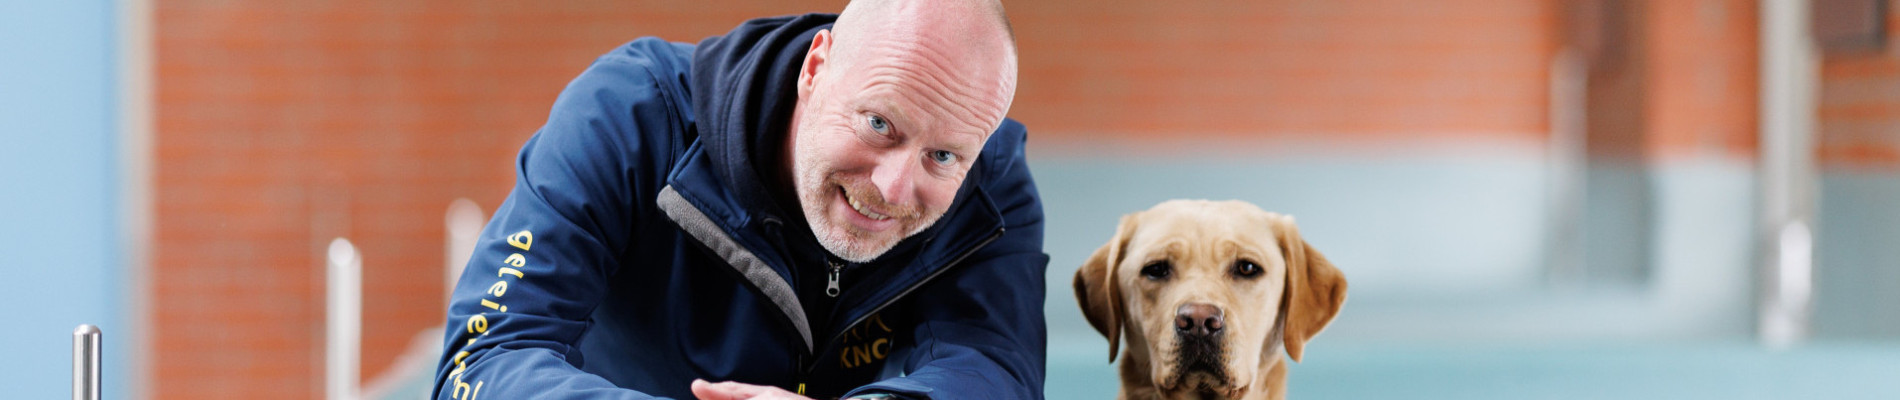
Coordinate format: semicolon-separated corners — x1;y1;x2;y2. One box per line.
1047;343;1900;400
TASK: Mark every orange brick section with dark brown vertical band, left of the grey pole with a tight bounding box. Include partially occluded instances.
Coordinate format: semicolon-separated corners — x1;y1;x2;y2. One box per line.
1564;0;1759;165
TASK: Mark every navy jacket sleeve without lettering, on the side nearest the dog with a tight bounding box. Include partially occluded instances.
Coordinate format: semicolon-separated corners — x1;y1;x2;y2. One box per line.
846;119;1049;398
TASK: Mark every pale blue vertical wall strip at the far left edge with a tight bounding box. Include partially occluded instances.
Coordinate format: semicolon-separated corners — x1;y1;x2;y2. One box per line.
0;0;133;398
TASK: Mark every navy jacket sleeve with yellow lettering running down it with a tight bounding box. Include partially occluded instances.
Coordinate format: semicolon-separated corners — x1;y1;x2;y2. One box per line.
433;40;684;400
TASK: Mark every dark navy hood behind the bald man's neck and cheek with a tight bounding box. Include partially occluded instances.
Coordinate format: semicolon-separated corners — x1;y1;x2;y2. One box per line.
692;13;838;218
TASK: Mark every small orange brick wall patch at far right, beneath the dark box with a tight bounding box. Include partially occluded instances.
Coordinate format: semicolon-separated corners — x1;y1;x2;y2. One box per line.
1818;0;1900;171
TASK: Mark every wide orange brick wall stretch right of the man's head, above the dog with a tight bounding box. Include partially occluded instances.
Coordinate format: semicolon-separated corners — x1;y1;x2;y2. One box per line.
1009;0;1558;140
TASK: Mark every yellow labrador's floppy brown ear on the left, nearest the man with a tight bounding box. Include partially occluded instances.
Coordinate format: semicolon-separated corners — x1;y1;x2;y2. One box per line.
1075;214;1136;362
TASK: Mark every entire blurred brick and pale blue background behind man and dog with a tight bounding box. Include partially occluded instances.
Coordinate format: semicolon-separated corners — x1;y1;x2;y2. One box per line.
0;0;1900;398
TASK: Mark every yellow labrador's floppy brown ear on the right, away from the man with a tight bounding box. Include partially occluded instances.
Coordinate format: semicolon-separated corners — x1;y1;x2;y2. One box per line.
1269;216;1345;362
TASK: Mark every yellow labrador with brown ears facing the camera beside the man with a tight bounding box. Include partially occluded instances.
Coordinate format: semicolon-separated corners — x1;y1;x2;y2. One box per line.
1075;201;1345;400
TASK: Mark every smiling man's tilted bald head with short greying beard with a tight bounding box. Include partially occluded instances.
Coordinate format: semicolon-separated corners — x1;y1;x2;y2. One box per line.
785;0;1017;262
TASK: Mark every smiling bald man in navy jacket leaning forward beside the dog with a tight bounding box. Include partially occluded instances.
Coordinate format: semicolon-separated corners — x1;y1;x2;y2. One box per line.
435;0;1049;400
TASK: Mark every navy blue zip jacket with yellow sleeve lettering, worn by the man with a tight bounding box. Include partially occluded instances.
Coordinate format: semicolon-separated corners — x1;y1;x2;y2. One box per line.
435;15;1049;400
